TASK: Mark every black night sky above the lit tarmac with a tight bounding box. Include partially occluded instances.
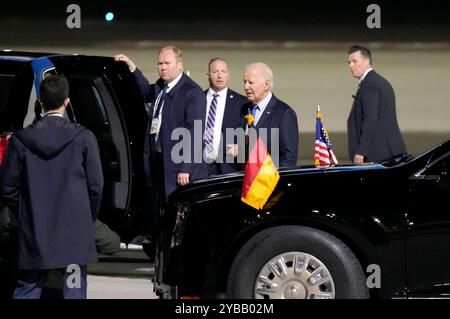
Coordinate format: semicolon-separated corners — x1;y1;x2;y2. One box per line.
0;0;450;44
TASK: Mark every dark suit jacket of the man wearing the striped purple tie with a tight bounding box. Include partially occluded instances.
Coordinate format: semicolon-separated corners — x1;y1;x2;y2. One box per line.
205;88;247;174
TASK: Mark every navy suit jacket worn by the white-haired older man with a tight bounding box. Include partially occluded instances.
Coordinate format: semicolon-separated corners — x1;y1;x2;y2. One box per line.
241;95;298;167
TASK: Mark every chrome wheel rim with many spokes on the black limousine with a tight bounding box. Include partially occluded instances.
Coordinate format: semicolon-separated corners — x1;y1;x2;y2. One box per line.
254;251;335;299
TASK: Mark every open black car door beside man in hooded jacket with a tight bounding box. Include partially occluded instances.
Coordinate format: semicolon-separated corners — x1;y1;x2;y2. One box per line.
49;56;146;242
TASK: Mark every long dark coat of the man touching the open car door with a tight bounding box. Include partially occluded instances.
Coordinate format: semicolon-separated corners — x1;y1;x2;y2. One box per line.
134;69;207;196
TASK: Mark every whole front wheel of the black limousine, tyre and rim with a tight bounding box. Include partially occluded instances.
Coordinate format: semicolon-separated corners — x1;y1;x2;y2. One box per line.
227;226;369;299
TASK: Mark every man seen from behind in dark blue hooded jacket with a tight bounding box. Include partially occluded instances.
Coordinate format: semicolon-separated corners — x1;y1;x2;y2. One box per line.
0;75;103;299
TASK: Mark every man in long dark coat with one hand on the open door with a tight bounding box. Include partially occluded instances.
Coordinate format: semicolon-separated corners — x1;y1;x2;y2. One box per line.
116;46;206;197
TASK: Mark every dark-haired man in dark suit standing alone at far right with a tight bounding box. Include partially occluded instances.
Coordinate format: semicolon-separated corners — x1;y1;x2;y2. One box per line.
347;46;406;164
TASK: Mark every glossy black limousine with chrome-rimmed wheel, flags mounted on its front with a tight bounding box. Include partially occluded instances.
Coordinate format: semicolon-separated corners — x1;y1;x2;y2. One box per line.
154;140;450;299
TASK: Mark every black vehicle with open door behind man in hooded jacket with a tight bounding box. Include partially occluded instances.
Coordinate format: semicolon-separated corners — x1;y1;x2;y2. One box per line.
0;51;146;251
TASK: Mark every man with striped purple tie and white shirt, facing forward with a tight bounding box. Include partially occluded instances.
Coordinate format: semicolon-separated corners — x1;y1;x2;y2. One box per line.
203;58;247;175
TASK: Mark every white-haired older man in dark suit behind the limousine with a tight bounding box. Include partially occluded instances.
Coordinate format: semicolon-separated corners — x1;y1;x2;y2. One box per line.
241;63;298;167
